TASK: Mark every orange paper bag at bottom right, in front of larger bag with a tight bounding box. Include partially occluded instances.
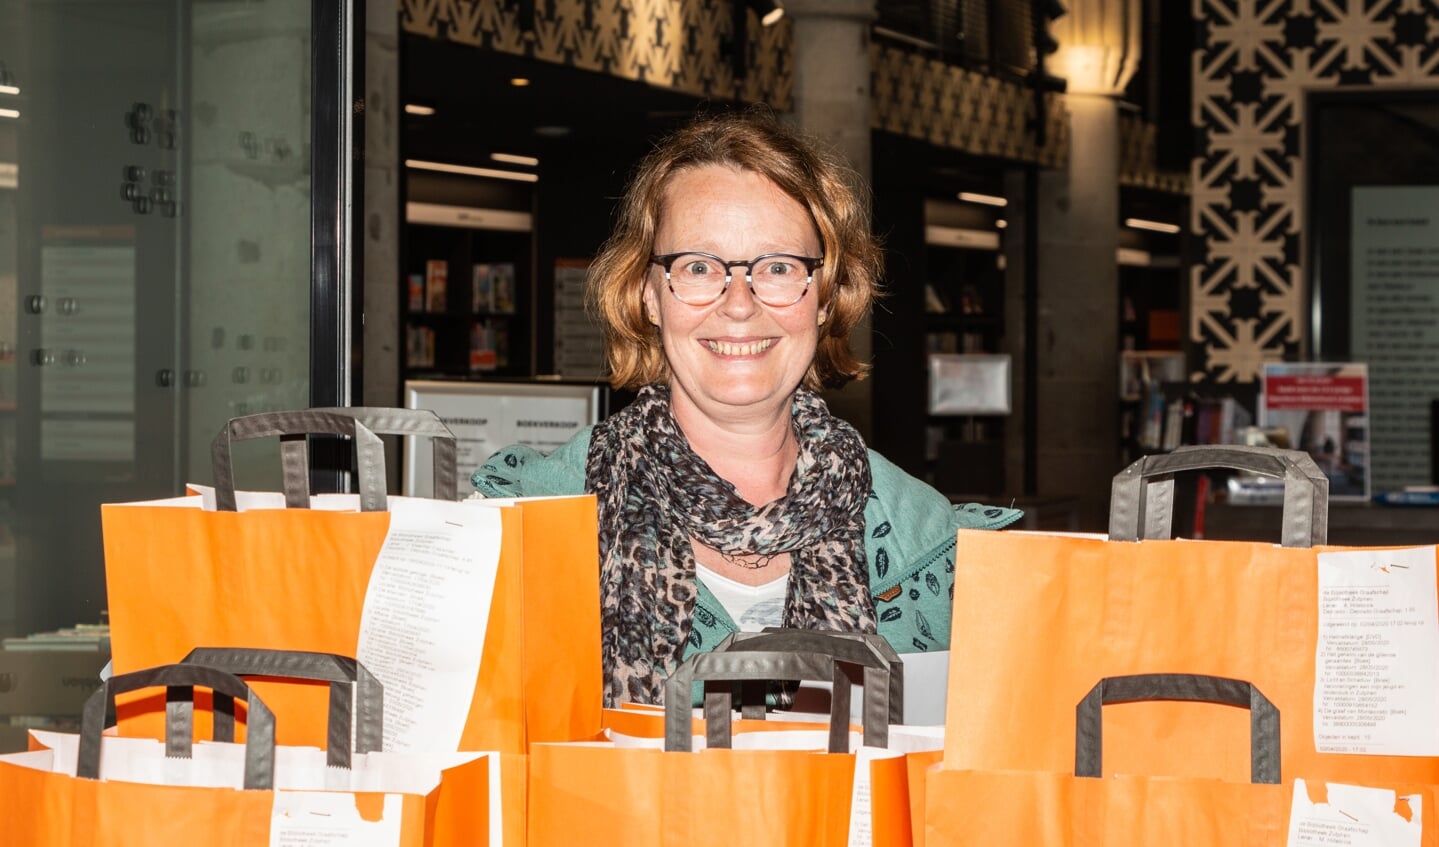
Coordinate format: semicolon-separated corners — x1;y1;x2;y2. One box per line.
925;674;1436;847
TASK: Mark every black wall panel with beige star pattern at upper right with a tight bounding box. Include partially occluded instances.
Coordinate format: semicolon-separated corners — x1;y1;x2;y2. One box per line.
1189;0;1439;383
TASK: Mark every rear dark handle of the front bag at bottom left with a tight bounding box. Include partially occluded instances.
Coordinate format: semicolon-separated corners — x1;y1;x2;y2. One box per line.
180;647;384;769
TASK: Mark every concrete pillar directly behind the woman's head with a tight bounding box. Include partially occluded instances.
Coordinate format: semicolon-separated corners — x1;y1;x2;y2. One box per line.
781;0;875;440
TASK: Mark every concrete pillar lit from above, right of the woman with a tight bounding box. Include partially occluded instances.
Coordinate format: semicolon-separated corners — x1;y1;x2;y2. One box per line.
1029;93;1120;529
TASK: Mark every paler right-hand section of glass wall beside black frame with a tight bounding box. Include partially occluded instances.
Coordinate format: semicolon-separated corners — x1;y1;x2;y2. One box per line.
180;0;311;489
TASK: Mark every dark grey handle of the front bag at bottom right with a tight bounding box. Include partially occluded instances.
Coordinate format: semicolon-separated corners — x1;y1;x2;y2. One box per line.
1075;673;1279;785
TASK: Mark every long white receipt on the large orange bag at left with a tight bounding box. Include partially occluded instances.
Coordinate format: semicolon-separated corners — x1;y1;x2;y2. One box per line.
355;498;501;752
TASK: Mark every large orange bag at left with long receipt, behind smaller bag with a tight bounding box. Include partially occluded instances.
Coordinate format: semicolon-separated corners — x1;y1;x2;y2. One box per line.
102;410;602;754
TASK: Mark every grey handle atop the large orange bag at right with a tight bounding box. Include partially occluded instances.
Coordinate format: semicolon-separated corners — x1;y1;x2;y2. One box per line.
1109;444;1330;546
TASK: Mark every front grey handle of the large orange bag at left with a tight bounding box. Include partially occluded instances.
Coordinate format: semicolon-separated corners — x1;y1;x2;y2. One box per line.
210;410;386;512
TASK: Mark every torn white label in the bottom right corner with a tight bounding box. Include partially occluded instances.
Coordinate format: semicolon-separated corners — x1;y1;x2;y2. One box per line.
1288;779;1423;847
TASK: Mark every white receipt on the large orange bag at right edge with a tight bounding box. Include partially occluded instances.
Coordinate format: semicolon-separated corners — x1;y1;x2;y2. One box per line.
1314;546;1439;756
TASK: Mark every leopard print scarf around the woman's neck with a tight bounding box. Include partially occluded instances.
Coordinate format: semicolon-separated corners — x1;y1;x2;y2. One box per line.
584;385;875;706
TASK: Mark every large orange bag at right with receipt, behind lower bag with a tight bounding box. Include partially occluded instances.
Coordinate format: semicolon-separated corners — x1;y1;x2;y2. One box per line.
944;447;1439;784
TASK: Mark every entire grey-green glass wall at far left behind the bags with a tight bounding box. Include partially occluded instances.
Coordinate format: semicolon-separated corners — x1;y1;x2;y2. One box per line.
0;0;311;743
